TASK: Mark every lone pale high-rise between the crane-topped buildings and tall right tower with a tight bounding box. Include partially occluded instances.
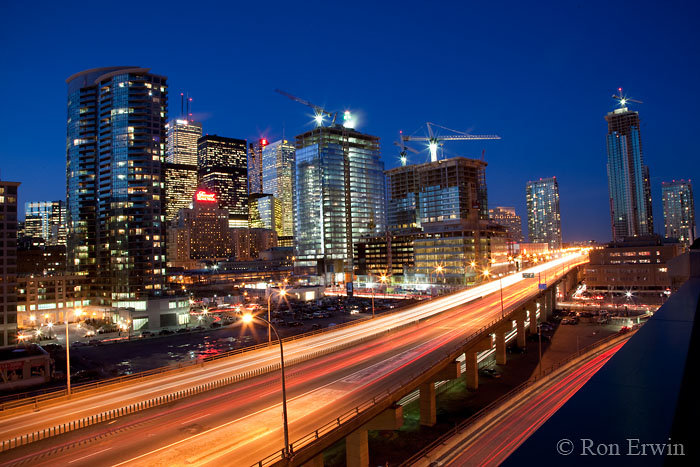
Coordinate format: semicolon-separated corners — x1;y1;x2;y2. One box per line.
525;177;561;250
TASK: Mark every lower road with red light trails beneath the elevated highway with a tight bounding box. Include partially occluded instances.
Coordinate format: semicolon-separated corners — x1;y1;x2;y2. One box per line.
411;336;629;467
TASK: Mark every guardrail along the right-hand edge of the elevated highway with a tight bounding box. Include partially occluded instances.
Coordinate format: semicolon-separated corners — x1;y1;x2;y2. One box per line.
252;261;588;467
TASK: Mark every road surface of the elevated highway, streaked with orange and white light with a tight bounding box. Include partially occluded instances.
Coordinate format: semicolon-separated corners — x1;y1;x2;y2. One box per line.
0;255;586;466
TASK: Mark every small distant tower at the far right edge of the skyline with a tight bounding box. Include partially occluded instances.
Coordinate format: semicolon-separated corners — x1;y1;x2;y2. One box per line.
661;180;696;246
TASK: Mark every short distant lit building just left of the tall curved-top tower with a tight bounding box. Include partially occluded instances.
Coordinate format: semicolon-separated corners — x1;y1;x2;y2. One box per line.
24;201;66;246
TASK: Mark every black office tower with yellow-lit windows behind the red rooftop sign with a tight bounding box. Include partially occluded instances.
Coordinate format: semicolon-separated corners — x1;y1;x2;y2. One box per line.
198;135;248;227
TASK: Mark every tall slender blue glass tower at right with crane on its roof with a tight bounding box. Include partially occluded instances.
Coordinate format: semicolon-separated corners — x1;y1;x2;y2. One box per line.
605;106;654;241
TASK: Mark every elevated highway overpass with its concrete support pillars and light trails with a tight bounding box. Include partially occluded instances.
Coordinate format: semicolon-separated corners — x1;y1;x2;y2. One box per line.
0;254;587;465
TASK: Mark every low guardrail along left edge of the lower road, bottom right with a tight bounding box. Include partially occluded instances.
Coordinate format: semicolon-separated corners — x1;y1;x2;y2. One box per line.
399;330;636;467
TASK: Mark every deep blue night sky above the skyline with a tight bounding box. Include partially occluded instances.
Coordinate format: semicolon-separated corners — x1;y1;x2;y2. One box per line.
0;1;700;241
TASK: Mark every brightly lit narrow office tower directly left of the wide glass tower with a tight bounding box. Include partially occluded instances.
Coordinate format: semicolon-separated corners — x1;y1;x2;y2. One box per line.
262;140;295;246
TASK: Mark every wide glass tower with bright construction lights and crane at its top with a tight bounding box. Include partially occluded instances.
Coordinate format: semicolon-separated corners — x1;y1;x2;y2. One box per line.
294;126;386;283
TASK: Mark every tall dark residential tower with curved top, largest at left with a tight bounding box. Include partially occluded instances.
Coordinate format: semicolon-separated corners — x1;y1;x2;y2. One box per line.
66;67;168;307
